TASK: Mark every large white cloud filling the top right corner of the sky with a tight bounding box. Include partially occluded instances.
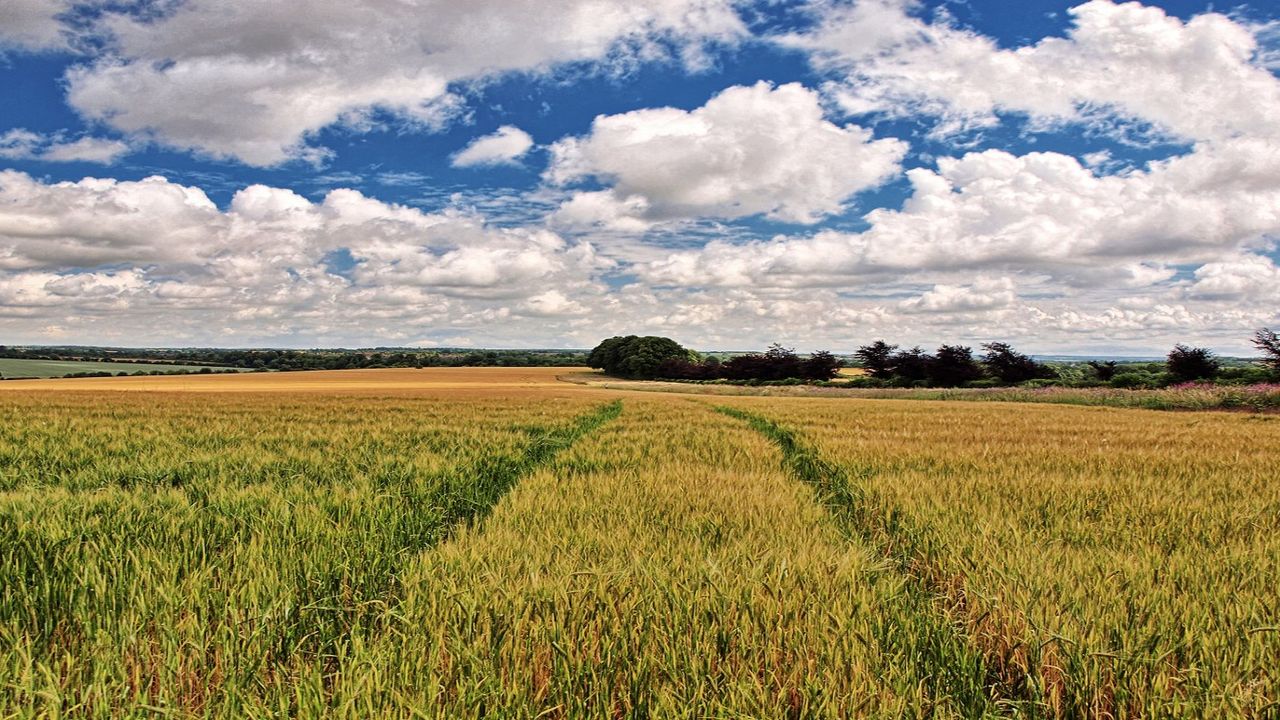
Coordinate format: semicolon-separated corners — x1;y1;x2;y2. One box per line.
783;0;1280;140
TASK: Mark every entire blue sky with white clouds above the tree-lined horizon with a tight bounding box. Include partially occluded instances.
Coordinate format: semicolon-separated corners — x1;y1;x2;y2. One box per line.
0;0;1280;355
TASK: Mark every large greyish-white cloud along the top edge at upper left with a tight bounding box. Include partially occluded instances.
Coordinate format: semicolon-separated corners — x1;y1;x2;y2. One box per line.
67;0;745;165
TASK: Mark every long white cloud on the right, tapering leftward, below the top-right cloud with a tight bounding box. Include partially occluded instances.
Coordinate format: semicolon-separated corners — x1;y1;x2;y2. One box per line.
648;143;1280;287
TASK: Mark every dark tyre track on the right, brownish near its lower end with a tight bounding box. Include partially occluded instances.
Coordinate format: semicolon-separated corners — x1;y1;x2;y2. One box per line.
716;406;1044;717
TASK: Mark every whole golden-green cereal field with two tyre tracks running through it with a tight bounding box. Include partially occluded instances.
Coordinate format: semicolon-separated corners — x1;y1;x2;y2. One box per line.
0;369;1280;719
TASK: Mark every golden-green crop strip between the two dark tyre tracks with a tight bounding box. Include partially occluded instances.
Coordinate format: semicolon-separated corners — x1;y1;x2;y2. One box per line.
368;398;996;720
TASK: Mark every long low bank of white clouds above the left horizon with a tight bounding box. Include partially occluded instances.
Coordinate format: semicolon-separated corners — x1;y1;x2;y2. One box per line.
0;170;609;342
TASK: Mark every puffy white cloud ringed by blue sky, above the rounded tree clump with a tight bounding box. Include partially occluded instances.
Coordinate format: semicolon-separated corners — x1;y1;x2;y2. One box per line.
547;82;906;227
